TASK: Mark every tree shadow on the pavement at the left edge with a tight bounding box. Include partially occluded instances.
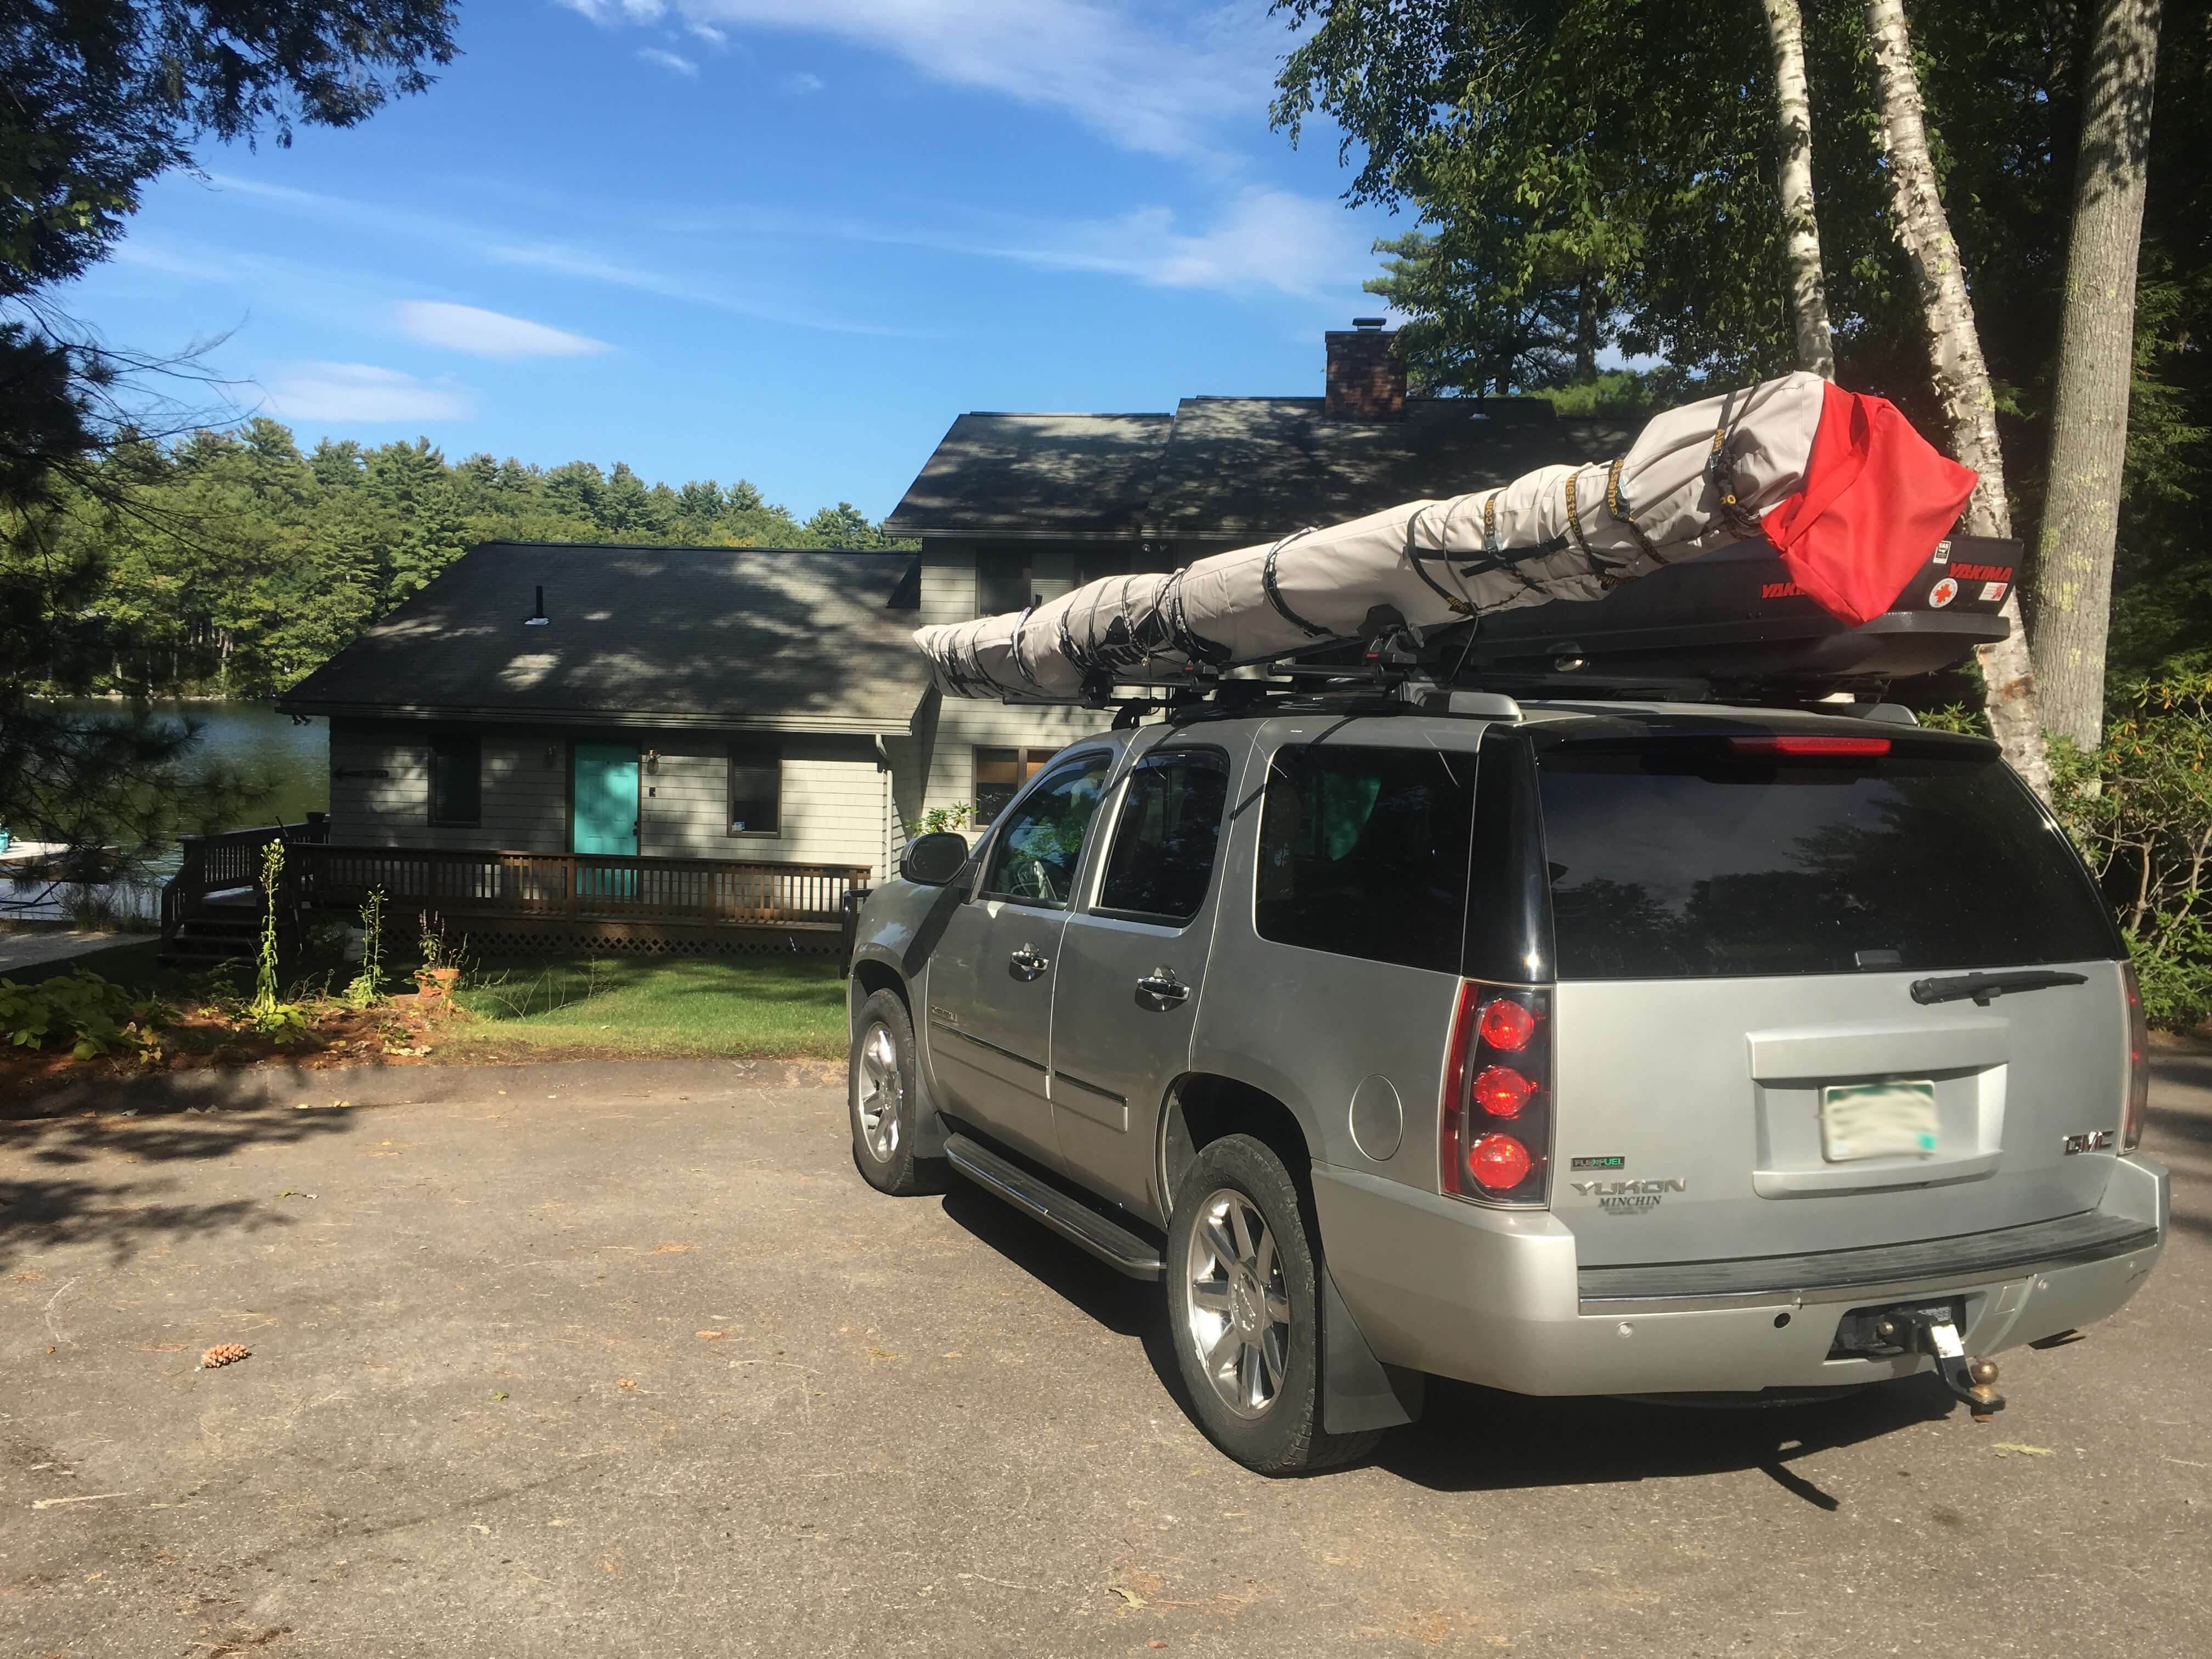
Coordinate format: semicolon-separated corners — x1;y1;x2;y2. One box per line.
0;1110;352;1272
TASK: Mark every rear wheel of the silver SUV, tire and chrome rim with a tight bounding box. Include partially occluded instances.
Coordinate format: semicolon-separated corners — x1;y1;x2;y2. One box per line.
1168;1135;1380;1475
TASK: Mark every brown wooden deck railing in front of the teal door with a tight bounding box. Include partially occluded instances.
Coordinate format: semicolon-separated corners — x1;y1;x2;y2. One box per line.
285;845;870;931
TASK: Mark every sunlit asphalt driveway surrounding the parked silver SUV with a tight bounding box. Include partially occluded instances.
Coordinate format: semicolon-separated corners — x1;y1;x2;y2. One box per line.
0;1053;2212;1659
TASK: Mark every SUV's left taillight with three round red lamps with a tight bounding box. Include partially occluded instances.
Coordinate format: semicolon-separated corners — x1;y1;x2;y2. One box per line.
1436;980;1550;1203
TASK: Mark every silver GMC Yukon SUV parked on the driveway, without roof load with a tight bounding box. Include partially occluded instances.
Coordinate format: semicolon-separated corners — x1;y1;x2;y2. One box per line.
851;684;2168;1473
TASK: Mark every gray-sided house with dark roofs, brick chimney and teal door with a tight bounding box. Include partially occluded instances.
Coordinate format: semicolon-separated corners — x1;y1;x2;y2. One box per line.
251;328;1630;955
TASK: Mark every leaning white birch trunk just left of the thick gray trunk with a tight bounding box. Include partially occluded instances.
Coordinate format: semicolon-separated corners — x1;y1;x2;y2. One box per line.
1867;0;2051;801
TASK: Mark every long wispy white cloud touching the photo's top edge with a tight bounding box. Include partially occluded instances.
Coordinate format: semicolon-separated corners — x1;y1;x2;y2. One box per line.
560;0;1290;157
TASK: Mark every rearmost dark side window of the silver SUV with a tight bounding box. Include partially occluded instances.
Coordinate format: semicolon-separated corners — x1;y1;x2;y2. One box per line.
1254;743;1475;973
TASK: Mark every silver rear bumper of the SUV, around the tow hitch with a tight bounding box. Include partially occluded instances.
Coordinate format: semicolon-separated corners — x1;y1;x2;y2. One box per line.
1314;1157;2168;1393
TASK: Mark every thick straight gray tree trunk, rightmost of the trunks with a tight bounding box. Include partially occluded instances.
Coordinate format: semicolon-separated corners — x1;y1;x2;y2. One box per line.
2035;0;2161;750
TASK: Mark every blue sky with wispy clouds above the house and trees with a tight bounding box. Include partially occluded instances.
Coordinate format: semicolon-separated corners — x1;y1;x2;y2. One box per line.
69;0;1404;515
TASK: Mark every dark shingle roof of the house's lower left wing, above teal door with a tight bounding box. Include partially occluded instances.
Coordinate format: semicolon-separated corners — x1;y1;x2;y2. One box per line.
279;542;927;732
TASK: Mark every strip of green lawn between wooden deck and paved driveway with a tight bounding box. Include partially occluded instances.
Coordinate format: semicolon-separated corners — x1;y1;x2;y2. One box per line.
444;956;845;1057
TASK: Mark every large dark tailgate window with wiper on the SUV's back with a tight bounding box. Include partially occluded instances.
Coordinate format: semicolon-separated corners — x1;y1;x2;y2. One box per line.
1537;737;2119;980
